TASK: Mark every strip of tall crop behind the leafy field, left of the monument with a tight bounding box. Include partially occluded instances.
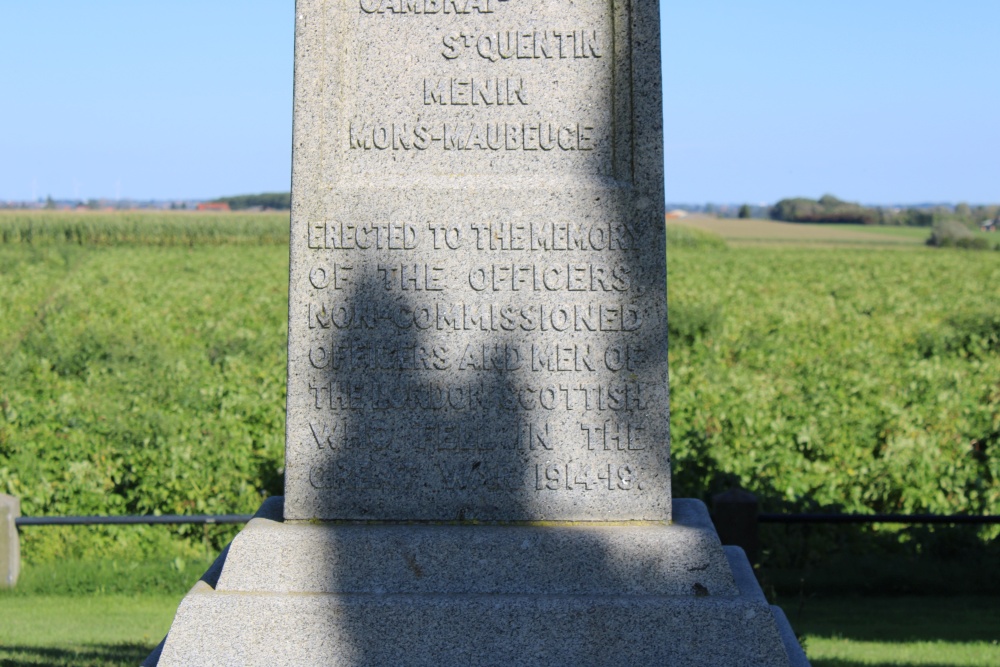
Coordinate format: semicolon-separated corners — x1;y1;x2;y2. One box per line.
0;210;288;246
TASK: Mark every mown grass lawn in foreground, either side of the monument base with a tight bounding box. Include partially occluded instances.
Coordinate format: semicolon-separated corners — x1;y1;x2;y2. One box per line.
0;595;1000;667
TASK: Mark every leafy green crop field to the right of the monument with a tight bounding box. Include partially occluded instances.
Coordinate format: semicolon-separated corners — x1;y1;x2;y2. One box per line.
668;248;1000;534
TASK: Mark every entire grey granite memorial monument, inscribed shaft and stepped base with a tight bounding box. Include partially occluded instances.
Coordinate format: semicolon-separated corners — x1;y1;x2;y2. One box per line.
146;0;806;667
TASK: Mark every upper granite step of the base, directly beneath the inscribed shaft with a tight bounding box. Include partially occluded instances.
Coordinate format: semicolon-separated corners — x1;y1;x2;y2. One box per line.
215;501;738;597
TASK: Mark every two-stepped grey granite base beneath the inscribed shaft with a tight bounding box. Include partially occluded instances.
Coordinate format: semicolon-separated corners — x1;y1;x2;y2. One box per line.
144;498;808;667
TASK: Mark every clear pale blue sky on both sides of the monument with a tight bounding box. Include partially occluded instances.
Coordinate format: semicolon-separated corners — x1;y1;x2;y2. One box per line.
0;0;1000;203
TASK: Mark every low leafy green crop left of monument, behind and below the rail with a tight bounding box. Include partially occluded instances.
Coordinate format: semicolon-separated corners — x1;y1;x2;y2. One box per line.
0;245;287;561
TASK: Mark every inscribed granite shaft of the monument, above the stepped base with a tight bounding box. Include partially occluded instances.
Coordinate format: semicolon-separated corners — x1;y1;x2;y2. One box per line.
285;0;670;521
